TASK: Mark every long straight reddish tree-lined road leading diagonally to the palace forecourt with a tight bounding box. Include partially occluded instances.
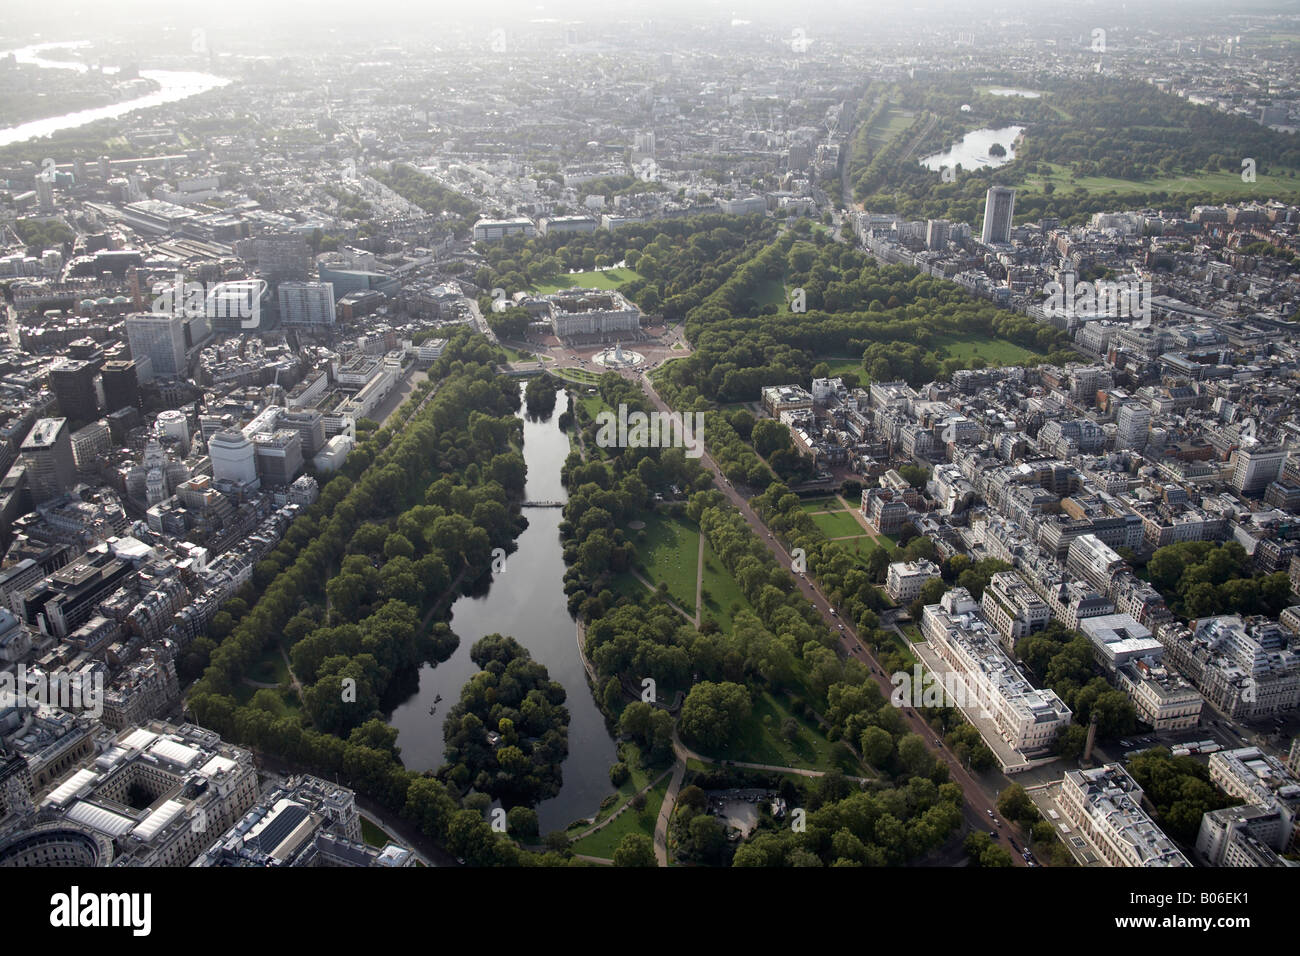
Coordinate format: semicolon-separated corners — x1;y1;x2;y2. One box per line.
624;372;1028;866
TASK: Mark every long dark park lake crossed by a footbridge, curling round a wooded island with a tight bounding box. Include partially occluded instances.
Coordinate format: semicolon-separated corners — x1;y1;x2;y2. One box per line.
389;392;618;835
